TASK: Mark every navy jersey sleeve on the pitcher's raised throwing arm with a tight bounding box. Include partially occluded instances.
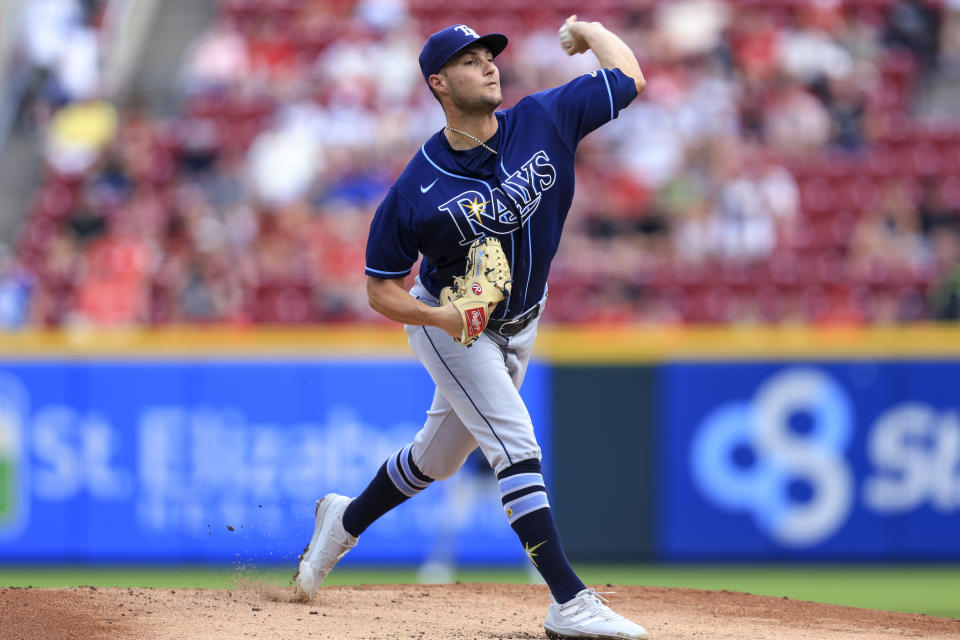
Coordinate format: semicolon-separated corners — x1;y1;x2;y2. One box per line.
531;69;637;150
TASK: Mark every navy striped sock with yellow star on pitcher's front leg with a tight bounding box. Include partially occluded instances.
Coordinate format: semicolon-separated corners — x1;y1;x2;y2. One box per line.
497;460;586;603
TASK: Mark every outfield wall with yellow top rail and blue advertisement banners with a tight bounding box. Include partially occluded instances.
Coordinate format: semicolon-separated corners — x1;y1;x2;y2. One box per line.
0;327;960;564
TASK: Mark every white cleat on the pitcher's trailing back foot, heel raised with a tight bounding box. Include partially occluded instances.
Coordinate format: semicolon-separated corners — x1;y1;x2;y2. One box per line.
293;493;357;598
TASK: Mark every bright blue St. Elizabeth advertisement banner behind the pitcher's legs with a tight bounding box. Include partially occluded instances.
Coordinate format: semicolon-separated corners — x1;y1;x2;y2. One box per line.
0;359;550;563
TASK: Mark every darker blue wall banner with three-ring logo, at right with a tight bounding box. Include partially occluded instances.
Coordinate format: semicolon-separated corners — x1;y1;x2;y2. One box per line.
658;361;960;560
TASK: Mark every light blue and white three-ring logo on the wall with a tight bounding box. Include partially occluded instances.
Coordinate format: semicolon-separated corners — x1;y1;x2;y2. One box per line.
689;367;854;548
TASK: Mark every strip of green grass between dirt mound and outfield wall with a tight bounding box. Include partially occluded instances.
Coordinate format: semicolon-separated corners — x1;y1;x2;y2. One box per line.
0;564;960;618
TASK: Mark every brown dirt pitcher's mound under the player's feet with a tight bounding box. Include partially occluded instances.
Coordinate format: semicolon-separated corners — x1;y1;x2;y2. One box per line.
0;583;960;640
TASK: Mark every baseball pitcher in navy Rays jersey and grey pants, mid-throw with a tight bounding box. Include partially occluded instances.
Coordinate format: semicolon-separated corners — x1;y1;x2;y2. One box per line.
296;16;647;638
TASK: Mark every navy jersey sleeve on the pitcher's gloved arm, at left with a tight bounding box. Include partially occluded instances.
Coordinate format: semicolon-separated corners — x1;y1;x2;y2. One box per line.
365;187;420;279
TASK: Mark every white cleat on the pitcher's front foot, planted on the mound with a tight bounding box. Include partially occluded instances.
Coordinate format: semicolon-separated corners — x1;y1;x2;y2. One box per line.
543;589;647;640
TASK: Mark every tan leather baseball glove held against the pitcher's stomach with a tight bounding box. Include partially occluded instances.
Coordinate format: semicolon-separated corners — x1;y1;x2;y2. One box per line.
440;238;513;345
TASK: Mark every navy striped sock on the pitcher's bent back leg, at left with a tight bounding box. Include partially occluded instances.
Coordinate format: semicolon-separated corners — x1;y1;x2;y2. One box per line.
343;444;433;537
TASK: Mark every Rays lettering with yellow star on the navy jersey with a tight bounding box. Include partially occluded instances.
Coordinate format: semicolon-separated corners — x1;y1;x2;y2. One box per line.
436;150;557;246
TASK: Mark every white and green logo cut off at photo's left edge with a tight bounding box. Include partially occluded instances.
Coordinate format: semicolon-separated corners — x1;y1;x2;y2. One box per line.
0;374;29;539
